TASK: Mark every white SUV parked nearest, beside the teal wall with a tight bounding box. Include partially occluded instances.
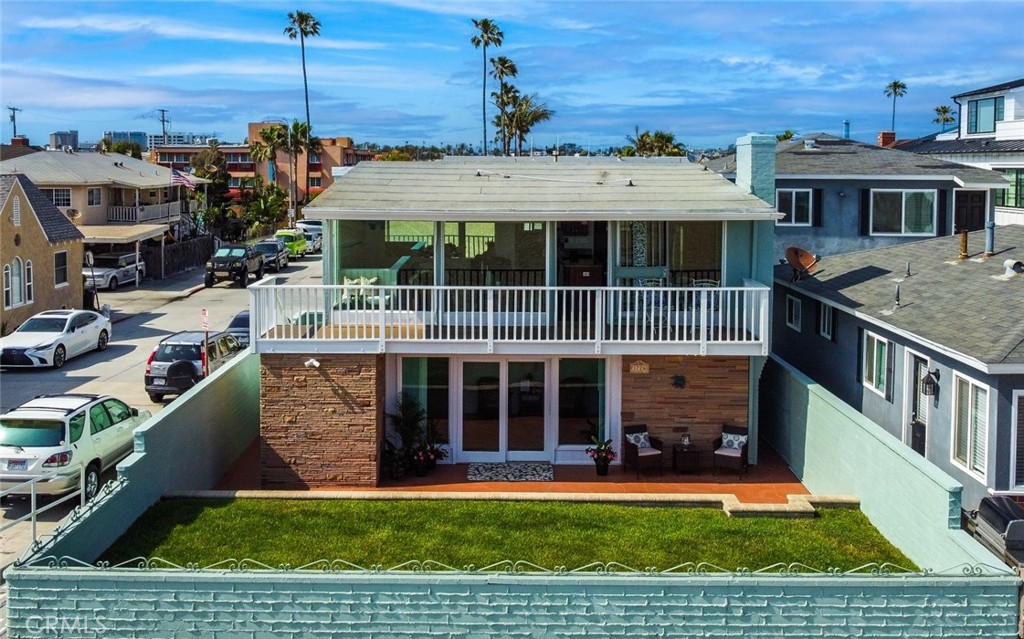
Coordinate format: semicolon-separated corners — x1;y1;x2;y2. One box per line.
0;393;150;500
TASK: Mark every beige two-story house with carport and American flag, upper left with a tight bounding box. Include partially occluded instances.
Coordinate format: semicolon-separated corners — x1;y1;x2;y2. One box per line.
0;151;206;278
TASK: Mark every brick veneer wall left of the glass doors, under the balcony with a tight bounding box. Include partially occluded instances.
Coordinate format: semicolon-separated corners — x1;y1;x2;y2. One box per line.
260;354;384;489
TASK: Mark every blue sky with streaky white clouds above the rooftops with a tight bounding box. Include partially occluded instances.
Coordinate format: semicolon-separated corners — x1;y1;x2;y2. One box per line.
0;0;1024;148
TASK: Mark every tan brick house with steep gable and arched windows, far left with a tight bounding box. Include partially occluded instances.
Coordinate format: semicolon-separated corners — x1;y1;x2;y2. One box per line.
0;174;83;335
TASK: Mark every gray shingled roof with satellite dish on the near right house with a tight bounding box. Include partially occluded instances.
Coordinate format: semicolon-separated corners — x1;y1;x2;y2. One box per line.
775;225;1024;366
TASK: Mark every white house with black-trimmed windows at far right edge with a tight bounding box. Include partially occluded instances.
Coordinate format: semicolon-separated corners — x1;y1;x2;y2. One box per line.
898;78;1024;224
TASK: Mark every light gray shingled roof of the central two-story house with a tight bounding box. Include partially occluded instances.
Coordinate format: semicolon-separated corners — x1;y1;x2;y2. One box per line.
305;158;778;221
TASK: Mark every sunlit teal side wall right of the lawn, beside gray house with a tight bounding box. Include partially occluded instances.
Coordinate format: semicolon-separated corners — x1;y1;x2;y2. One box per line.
759;356;1009;570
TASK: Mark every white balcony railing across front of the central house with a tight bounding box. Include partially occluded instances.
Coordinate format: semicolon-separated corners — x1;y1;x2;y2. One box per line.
249;278;769;355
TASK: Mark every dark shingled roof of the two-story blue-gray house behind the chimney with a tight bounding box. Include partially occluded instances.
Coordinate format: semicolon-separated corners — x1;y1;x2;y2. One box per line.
709;133;1009;188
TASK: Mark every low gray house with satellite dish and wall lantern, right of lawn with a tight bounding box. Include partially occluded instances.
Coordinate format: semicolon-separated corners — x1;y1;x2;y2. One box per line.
772;225;1024;509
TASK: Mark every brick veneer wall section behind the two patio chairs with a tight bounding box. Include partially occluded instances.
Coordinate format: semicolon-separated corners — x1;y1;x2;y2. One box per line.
622;355;750;464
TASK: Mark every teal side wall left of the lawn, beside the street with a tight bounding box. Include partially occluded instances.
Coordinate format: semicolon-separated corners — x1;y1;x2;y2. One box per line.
26;352;260;562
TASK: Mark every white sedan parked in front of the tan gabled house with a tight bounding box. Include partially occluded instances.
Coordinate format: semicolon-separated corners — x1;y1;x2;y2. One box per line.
0;308;113;369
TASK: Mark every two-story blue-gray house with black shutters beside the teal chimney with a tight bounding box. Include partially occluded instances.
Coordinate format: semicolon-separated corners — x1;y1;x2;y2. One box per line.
709;133;1009;257
